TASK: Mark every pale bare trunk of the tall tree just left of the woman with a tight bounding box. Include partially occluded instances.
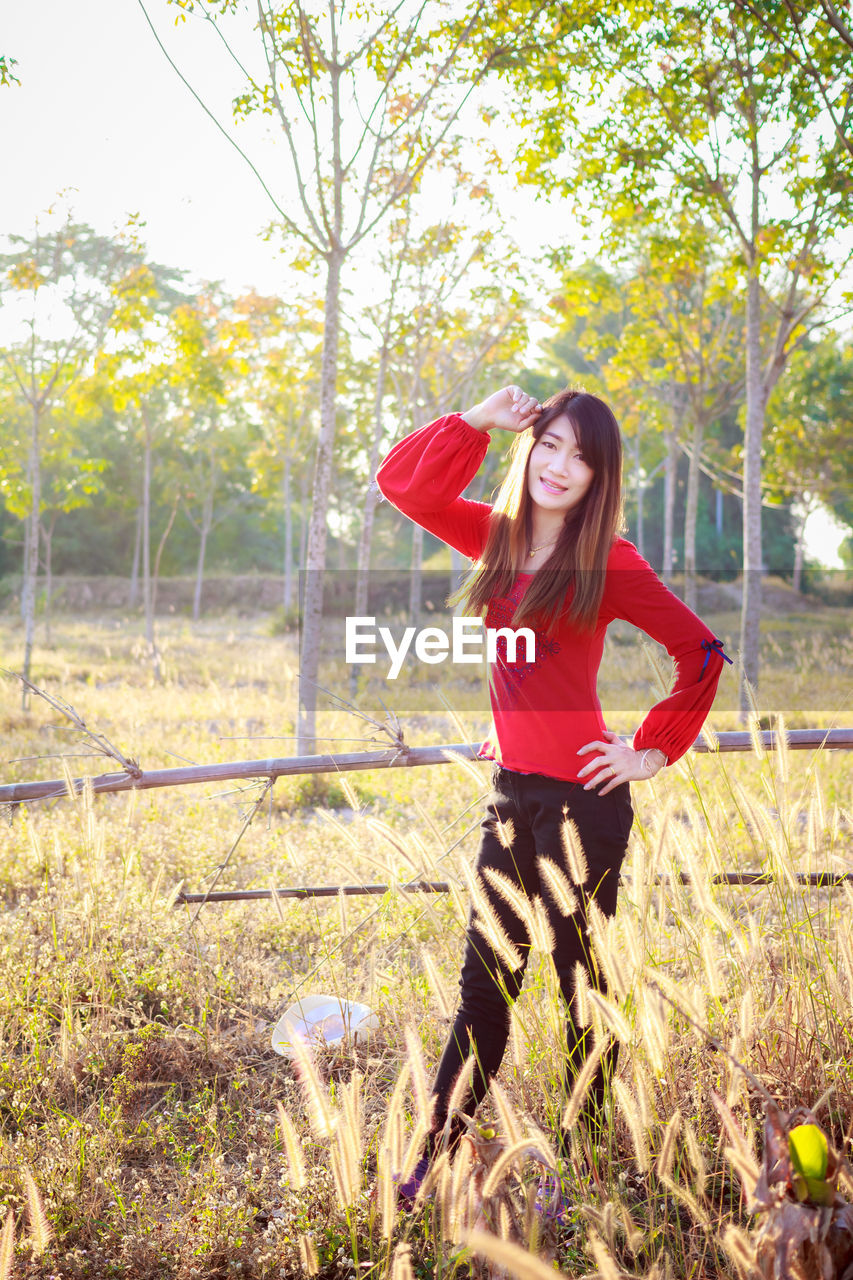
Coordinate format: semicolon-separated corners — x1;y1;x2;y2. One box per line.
297;246;343;755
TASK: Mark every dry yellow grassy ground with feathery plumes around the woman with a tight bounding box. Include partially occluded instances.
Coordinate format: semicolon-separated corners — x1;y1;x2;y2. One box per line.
0;611;853;1280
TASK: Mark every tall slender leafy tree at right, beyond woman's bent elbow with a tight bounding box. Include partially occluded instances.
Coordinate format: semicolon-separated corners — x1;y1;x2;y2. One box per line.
512;0;853;714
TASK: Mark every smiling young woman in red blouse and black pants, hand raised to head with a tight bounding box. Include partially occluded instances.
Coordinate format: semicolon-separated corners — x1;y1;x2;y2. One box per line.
377;387;730;1202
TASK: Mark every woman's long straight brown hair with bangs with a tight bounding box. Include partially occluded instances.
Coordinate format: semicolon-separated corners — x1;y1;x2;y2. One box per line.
451;390;622;632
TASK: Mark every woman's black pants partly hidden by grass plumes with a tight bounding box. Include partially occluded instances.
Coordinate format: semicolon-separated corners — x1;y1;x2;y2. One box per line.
430;767;634;1148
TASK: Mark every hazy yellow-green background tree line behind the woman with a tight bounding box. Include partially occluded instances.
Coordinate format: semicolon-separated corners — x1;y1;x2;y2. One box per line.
0;223;853;586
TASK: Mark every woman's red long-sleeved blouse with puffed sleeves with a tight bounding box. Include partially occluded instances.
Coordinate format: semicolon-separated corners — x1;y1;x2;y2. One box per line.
377;413;724;782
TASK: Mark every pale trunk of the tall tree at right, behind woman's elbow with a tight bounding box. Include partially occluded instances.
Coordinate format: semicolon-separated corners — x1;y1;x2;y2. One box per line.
740;260;765;723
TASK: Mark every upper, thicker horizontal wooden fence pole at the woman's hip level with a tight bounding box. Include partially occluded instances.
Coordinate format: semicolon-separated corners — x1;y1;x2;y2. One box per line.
0;728;853;804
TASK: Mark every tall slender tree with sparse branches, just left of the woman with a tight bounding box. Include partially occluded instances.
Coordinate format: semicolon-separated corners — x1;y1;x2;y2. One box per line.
151;0;546;751
